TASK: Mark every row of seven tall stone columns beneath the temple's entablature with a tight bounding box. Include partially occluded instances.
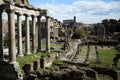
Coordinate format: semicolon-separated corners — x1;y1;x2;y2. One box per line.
0;10;50;64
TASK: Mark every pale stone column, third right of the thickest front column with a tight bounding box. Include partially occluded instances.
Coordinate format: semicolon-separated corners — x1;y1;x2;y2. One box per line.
32;16;36;53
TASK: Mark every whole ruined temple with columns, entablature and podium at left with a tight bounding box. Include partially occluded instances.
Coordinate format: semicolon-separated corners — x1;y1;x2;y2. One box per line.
0;0;59;80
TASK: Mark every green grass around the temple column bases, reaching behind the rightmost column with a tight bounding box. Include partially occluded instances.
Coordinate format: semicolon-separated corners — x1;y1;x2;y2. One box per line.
17;40;62;67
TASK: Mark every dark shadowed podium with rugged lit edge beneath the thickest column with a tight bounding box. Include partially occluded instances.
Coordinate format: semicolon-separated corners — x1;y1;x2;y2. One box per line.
0;62;23;80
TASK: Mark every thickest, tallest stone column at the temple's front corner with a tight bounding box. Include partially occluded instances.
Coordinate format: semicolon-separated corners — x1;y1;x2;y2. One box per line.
8;10;16;64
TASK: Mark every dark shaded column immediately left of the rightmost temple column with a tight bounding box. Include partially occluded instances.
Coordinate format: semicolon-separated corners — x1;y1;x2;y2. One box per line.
37;16;42;51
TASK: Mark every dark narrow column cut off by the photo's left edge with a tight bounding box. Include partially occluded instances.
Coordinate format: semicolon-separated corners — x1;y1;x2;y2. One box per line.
0;11;4;60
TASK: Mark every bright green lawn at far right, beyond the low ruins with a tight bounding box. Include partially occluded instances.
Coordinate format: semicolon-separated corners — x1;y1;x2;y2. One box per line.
90;49;120;67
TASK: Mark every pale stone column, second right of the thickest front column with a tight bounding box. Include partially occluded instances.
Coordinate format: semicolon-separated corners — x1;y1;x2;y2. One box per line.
25;15;31;55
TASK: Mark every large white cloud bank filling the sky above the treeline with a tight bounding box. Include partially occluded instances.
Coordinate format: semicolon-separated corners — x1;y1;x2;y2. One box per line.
40;0;120;23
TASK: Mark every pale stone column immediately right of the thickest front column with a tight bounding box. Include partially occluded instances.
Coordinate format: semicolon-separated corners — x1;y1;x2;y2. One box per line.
17;13;23;57
